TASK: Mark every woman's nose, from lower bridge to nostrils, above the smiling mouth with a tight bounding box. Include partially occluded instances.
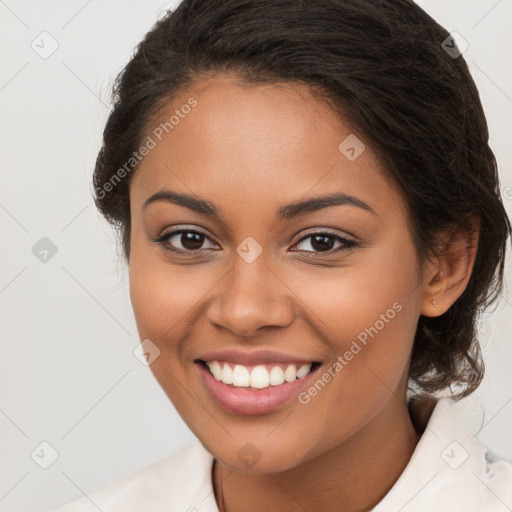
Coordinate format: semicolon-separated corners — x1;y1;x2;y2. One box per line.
207;256;294;337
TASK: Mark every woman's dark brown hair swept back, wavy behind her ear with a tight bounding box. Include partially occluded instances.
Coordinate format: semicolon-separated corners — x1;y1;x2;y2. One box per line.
93;0;511;398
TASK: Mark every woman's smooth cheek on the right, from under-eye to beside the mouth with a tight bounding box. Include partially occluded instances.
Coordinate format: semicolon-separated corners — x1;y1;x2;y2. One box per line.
282;237;421;396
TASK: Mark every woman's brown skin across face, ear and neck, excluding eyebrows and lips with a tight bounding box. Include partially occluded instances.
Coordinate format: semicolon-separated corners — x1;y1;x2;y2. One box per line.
129;75;475;512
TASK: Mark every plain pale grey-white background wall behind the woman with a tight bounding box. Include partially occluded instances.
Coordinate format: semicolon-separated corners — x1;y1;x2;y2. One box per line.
0;0;512;511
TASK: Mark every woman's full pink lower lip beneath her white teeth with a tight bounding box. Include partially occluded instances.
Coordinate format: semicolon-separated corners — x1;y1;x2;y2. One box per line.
196;363;320;416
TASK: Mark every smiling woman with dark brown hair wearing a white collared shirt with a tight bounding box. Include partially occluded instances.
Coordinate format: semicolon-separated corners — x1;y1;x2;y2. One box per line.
50;0;512;512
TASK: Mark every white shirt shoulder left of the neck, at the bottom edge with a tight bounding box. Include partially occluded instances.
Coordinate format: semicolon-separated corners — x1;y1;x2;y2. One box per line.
48;440;217;512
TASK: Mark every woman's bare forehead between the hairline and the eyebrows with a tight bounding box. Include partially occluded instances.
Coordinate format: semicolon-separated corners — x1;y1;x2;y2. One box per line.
130;76;399;219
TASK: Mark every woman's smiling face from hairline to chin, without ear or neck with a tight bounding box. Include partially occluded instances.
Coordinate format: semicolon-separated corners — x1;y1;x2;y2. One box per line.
129;76;424;472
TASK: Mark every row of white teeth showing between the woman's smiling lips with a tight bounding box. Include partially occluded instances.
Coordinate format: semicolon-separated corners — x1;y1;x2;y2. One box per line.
197;360;320;390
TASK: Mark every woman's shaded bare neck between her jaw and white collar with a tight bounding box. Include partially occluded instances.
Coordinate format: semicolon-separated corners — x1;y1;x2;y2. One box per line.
214;397;420;512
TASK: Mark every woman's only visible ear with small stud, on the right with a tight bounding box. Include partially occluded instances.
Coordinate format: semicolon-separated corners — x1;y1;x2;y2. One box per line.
421;217;480;317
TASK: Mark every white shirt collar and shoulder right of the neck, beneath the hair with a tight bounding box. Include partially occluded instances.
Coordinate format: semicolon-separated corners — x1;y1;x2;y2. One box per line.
373;398;512;512
